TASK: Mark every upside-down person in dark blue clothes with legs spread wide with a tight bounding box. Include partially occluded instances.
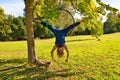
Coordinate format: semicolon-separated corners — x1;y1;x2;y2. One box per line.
34;19;80;62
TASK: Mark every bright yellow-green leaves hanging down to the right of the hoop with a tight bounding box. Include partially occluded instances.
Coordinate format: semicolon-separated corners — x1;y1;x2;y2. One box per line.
71;0;105;36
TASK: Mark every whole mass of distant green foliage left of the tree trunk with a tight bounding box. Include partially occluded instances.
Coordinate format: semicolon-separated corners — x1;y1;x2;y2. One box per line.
0;15;26;41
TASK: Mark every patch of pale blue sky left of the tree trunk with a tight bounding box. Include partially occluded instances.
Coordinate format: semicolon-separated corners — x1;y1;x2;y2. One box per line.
0;0;25;17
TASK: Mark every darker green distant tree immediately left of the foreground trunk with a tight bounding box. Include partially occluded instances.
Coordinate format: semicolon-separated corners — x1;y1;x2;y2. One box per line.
10;16;26;40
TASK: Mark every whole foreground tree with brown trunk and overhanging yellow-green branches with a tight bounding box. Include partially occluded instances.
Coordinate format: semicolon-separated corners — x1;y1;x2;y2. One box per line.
24;0;118;63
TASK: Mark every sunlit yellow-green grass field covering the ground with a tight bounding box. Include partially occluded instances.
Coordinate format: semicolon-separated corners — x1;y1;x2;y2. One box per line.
0;33;120;80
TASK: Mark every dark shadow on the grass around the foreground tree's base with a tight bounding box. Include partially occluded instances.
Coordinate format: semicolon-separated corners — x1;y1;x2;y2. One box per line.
0;59;79;80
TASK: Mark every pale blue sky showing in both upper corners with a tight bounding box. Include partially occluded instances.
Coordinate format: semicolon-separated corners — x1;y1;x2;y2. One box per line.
0;0;120;17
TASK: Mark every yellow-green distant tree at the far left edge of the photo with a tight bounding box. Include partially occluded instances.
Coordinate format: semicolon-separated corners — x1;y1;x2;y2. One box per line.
0;7;12;41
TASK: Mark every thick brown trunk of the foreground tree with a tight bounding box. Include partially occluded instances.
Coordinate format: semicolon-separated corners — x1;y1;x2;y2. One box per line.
24;0;37;64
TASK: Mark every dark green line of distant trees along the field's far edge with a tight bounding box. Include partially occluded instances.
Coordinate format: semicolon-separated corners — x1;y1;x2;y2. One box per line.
0;7;120;41
